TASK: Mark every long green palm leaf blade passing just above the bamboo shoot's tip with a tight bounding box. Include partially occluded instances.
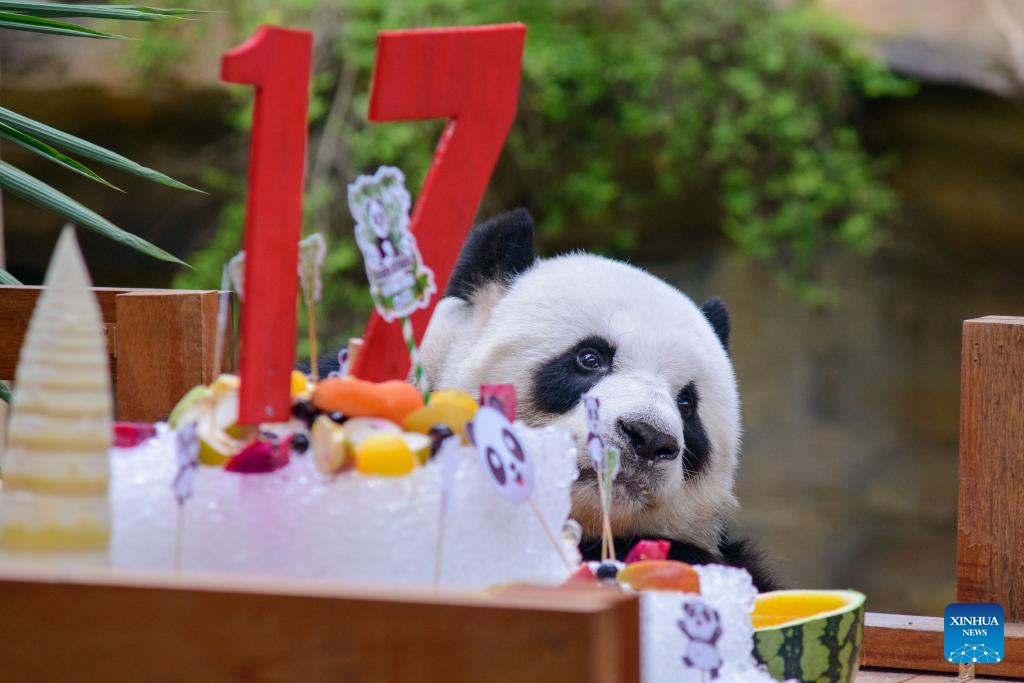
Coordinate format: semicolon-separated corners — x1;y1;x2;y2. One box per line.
0;161;188;265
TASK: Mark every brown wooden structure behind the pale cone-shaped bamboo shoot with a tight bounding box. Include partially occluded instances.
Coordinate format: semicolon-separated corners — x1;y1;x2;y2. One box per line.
0;286;233;422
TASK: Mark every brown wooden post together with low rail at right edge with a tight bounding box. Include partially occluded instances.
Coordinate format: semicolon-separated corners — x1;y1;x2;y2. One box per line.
862;315;1024;678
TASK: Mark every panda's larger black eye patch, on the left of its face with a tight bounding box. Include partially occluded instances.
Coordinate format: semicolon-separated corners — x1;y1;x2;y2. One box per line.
532;336;615;415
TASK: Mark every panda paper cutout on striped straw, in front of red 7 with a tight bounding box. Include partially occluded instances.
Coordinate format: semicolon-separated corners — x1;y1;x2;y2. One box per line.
348;166;437;323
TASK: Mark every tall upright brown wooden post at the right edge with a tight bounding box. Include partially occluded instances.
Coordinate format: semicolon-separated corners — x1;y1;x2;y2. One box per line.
956;315;1024;622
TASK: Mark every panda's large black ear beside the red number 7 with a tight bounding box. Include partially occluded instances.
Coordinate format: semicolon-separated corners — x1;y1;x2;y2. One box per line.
444;208;537;301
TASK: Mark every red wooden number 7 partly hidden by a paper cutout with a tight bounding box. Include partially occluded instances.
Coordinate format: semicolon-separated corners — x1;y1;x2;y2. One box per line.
352;24;526;386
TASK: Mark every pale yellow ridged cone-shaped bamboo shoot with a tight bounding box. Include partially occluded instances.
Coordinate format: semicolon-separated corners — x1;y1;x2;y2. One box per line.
0;227;113;554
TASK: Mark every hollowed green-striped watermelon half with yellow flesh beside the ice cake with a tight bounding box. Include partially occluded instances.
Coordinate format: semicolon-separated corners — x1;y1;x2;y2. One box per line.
753;591;864;683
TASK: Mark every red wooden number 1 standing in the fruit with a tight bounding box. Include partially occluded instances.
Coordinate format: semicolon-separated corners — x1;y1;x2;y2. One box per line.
220;27;312;424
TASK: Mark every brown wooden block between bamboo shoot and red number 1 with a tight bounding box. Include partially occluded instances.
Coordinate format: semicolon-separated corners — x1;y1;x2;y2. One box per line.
116;291;225;422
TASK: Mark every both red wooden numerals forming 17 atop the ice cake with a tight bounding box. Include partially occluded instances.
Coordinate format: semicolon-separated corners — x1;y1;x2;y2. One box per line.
222;24;526;424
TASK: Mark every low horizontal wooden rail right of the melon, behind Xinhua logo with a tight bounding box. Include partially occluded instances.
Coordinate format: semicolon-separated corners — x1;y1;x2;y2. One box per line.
861;612;1024;678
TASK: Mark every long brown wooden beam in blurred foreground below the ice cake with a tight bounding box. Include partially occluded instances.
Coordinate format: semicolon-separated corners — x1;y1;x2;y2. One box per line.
0;568;640;683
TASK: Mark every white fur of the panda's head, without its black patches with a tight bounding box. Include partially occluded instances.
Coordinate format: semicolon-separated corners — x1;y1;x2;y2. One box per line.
421;254;740;550
